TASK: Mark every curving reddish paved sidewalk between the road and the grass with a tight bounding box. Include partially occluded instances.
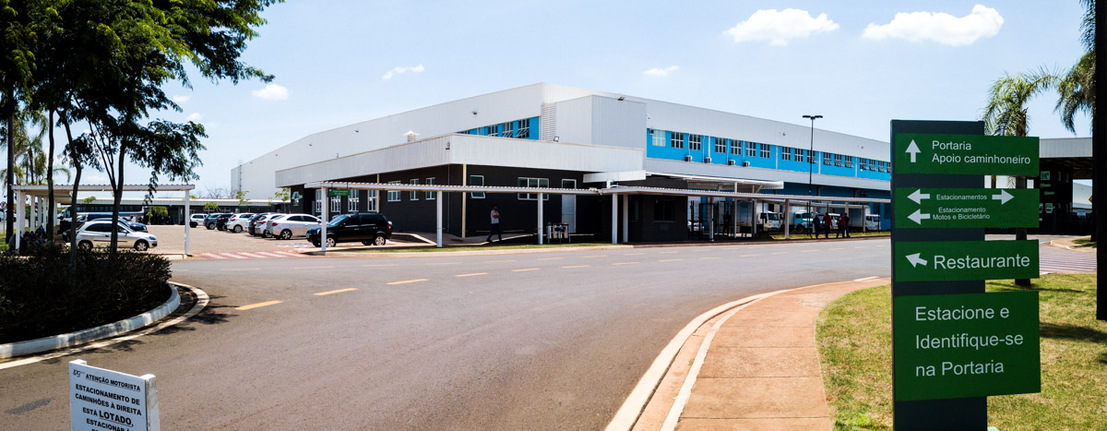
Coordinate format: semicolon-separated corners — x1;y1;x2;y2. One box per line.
634;278;890;431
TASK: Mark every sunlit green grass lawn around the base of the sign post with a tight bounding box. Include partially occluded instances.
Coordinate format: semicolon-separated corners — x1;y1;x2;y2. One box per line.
817;275;1107;431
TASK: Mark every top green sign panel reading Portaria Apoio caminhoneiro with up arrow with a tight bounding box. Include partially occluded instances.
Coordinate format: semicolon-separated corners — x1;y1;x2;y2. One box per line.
892;133;1038;176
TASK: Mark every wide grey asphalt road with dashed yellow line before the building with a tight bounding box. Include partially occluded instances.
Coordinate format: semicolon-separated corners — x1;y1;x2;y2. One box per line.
0;238;890;430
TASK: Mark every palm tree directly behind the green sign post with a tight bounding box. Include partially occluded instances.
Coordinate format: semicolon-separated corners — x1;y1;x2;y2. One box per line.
983;70;1057;286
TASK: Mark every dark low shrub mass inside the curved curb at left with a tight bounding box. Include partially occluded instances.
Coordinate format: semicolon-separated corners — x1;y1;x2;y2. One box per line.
0;247;170;342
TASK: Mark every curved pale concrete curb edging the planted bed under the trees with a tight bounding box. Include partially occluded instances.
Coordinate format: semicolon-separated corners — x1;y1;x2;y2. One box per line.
0;284;180;359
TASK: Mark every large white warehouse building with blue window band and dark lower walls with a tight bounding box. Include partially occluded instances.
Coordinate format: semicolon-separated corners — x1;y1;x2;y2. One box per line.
231;83;891;242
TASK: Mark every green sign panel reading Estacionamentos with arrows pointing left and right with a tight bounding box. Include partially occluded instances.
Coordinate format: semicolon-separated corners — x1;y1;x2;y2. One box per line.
894;187;1038;228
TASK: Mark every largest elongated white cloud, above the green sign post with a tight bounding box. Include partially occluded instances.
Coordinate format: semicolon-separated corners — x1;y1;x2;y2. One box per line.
861;4;1003;47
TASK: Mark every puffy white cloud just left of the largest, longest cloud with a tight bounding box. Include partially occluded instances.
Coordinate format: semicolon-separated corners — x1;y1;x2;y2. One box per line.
726;9;838;47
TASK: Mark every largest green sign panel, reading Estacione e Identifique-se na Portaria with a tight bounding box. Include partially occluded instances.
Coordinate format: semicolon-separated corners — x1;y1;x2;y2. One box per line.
892;290;1042;401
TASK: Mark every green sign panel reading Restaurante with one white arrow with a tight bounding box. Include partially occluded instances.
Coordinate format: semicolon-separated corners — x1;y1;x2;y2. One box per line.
893;240;1038;281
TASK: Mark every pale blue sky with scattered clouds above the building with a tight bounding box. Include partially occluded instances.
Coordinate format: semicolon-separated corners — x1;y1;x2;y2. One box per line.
110;0;1089;193
